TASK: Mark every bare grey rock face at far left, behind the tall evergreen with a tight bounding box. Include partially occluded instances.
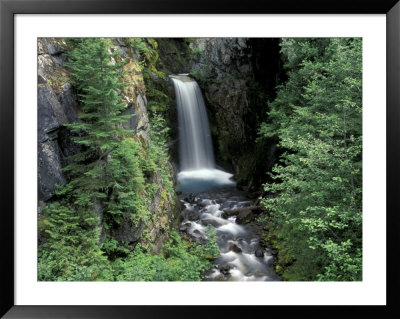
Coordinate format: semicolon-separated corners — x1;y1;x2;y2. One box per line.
37;38;79;202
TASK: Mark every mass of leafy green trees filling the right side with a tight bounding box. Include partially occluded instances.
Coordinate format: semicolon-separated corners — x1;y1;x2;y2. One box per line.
260;38;362;280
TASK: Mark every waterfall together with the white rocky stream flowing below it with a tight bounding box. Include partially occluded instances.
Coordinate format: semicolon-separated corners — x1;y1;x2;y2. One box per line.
170;75;279;281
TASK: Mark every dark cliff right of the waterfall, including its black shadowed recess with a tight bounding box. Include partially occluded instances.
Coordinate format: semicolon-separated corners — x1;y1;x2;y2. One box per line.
191;38;283;192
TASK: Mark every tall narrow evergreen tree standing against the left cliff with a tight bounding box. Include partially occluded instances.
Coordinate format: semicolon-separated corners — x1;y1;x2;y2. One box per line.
60;38;131;206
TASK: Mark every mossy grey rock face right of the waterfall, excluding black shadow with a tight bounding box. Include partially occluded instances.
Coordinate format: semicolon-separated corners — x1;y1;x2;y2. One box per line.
193;38;253;159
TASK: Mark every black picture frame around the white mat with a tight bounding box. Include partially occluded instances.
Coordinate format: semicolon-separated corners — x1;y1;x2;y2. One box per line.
0;0;400;318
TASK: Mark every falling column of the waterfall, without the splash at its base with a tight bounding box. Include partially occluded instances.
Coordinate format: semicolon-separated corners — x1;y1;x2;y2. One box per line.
172;76;215;171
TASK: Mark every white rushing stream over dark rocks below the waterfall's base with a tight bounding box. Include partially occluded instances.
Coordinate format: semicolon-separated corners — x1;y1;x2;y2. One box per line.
180;185;280;281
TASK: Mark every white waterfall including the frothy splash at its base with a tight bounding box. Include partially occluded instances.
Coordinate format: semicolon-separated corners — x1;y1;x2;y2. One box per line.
171;75;235;193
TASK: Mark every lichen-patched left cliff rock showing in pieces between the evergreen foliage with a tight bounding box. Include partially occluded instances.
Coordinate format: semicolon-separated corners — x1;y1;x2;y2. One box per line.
38;38;180;252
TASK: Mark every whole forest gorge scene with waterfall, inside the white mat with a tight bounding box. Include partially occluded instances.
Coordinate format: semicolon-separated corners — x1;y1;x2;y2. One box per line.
38;38;362;281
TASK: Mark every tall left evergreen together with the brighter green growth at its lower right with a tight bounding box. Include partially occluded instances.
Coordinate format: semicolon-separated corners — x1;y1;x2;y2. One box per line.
58;39;148;228
